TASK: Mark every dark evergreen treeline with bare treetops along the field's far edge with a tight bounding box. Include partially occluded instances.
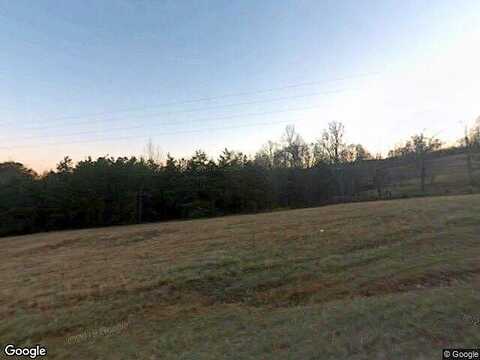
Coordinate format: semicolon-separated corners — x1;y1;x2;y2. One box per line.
0;122;480;236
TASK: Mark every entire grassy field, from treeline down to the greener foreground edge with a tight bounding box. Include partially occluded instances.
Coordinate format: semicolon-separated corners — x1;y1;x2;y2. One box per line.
0;195;480;359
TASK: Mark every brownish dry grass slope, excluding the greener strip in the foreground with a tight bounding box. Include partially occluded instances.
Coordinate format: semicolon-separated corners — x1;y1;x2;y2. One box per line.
0;196;480;357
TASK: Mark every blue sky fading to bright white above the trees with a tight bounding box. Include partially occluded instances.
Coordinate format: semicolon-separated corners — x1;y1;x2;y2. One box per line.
0;0;480;172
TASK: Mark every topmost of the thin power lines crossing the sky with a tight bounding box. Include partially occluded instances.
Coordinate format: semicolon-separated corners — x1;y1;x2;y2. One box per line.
0;72;380;125
